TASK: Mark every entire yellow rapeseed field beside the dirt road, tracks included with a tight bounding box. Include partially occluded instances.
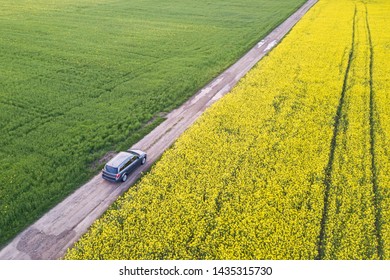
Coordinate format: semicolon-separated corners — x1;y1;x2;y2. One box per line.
65;0;390;259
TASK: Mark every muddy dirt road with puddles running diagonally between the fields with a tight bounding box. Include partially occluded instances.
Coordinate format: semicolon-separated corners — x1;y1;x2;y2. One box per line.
0;0;317;259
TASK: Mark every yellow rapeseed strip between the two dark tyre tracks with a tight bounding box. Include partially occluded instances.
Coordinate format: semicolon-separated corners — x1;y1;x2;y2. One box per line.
324;2;378;259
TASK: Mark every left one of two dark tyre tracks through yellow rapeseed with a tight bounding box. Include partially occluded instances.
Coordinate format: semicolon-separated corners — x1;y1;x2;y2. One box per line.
316;5;357;260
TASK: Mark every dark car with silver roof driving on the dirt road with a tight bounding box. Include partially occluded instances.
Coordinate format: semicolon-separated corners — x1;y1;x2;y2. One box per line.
102;150;146;182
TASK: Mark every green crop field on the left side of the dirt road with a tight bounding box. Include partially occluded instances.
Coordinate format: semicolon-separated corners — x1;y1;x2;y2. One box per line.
0;0;305;245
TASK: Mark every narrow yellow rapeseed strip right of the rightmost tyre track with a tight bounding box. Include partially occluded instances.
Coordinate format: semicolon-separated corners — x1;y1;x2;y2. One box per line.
367;0;390;259
